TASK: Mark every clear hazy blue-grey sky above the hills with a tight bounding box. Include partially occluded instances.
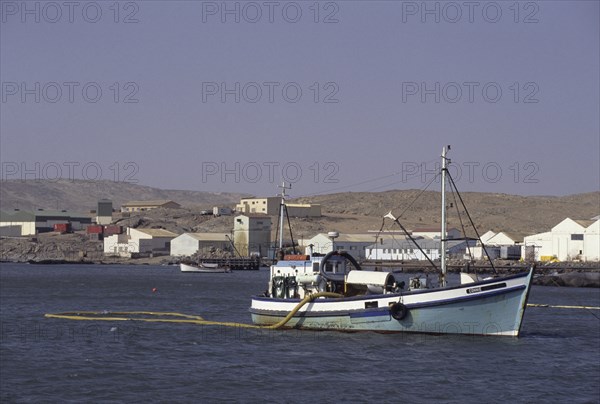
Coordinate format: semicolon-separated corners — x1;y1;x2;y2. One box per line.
0;0;600;197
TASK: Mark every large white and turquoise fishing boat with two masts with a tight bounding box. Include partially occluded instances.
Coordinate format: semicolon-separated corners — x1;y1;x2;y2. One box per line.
250;146;534;336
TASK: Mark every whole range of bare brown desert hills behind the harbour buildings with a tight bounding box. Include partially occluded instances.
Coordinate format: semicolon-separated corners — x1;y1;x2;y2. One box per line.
0;180;600;239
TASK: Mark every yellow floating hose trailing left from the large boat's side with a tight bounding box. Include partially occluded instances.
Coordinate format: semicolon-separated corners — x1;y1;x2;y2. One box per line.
44;292;343;330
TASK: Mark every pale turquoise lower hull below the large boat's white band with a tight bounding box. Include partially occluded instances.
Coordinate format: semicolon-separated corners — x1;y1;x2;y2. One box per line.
251;288;526;335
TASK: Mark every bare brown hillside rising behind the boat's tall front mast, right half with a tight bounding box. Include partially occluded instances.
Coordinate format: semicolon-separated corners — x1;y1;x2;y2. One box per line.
298;190;600;234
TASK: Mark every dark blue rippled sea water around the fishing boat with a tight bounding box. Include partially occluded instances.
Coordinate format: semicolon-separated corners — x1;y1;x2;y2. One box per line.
0;264;600;403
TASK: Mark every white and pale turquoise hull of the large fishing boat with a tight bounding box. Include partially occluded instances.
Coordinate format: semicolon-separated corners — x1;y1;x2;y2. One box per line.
250;270;533;336
